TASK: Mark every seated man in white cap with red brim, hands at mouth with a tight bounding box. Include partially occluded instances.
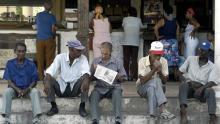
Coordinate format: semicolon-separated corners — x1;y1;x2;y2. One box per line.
137;41;175;120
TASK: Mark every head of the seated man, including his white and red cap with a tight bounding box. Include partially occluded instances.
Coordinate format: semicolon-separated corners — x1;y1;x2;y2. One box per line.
150;41;164;62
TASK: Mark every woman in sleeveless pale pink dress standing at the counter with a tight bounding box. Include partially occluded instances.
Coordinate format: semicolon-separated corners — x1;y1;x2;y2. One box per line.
90;5;111;58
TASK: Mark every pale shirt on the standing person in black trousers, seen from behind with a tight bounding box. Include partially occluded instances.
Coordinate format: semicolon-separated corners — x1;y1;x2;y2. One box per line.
122;17;143;46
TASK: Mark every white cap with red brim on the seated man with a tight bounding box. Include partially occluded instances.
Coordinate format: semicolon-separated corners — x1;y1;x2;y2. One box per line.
150;41;164;55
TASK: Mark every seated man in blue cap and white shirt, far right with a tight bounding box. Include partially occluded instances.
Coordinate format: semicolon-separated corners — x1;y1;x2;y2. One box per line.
179;41;220;124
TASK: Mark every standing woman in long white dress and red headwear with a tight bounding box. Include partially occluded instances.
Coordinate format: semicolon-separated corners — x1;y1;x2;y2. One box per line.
184;8;200;58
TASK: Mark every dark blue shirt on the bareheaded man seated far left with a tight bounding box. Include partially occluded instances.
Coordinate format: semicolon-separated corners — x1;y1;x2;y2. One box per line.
3;58;38;89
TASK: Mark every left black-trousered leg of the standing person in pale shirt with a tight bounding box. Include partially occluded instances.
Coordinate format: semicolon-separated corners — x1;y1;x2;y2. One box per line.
123;46;130;78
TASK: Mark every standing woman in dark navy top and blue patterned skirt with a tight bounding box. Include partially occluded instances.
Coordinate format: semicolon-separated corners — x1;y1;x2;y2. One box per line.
154;6;179;69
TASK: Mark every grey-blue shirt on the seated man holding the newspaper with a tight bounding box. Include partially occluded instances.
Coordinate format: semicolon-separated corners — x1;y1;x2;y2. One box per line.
91;57;127;94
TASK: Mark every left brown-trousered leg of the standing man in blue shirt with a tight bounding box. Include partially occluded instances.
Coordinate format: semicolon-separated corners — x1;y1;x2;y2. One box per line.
36;41;45;80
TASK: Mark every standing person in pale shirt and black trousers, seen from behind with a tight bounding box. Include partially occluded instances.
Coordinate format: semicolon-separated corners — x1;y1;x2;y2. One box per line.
122;7;143;81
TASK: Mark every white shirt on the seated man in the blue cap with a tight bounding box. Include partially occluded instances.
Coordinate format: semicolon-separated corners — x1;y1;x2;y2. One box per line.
179;56;220;85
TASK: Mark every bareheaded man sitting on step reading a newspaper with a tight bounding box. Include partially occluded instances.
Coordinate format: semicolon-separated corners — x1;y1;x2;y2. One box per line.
90;42;127;124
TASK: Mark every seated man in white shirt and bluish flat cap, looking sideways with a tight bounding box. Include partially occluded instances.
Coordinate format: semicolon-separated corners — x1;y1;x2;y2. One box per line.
44;40;90;117
